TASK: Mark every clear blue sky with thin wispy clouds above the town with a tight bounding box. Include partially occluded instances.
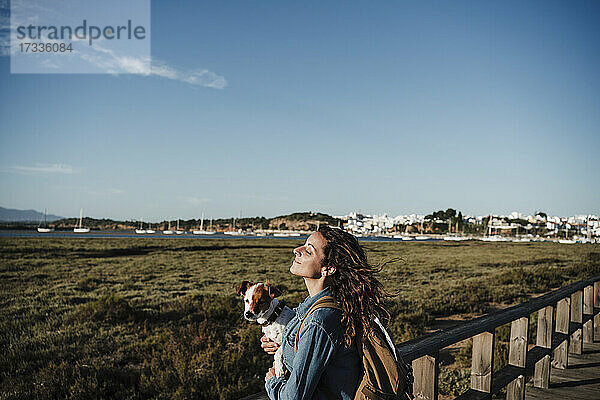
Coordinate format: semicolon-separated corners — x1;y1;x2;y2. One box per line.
0;0;600;221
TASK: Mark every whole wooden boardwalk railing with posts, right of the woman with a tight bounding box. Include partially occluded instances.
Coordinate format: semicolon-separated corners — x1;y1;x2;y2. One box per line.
397;276;600;400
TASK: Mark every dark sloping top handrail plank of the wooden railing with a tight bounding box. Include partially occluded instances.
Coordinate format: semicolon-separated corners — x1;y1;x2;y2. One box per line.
397;276;600;361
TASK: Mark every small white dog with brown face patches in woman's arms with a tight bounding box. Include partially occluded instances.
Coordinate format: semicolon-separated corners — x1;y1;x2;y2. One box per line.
237;281;295;378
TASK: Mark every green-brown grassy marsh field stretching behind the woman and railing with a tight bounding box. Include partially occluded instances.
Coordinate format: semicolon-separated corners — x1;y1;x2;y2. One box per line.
0;237;600;399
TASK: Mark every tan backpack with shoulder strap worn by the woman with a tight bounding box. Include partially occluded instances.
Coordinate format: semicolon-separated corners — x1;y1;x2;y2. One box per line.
294;296;414;400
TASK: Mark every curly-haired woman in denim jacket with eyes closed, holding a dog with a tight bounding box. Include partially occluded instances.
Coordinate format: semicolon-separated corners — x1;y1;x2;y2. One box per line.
261;226;388;400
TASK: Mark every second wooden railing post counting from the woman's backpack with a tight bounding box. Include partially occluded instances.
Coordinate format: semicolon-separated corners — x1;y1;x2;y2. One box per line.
471;332;494;393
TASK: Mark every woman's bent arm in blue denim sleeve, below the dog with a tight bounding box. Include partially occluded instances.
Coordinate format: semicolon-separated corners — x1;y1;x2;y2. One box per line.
265;322;335;400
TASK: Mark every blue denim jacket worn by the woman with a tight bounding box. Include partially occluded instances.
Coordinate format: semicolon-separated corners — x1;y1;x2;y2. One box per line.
265;288;361;400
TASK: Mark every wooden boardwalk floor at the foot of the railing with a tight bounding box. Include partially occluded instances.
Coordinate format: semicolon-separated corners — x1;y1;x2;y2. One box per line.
525;341;600;400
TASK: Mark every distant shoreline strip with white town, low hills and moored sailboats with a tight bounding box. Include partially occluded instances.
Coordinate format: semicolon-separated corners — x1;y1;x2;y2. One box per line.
0;208;600;243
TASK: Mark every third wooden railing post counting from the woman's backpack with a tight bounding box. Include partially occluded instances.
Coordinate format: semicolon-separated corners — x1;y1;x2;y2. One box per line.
506;317;529;400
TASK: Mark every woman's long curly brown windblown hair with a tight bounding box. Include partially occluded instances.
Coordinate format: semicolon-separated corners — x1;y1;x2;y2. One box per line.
318;225;390;346
